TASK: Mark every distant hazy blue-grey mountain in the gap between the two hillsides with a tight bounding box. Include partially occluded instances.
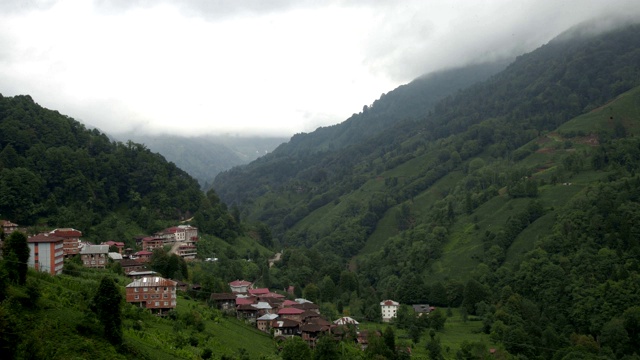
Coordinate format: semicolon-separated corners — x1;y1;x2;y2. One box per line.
117;133;287;189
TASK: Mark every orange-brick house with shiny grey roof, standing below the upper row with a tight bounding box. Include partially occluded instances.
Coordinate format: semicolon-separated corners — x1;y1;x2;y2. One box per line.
126;276;176;315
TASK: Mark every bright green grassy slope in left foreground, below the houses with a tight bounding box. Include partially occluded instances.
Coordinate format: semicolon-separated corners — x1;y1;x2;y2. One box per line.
25;269;275;359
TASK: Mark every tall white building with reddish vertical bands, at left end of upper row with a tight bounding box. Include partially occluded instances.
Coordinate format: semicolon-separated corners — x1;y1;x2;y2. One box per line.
27;233;64;275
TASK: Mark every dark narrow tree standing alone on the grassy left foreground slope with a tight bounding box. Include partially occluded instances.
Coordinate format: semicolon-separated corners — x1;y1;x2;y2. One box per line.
92;276;123;345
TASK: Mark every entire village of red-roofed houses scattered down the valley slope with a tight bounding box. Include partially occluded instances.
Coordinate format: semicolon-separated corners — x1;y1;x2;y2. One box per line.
0;220;434;349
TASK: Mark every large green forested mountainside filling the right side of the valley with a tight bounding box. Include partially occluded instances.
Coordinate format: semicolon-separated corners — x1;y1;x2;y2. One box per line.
214;21;640;359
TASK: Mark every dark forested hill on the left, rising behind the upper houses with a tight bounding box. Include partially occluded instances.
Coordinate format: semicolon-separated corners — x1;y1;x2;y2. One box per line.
0;95;239;245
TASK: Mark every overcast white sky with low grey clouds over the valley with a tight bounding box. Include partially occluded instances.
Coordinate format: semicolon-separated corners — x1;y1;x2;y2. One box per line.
0;0;640;136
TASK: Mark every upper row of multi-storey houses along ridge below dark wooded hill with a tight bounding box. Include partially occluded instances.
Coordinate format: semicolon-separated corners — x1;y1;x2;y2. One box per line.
0;220;198;275
